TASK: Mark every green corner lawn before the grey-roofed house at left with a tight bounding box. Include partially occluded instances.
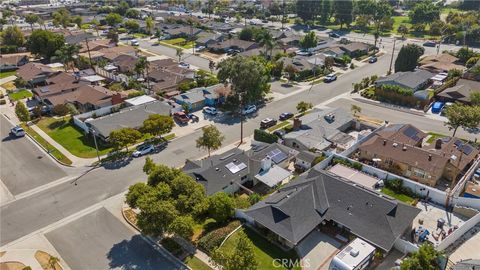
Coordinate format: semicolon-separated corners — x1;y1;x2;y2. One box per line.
37;117;112;158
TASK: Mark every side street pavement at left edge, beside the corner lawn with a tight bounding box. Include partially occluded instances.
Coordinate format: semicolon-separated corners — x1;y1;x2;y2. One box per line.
0;115;67;195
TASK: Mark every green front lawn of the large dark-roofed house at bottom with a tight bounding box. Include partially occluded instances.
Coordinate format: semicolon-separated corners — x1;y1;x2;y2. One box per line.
221;227;300;270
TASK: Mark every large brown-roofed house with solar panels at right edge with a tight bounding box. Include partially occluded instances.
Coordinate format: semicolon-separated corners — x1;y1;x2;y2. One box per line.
358;124;479;186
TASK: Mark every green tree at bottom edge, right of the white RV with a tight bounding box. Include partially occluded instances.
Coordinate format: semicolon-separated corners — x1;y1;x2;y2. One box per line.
400;243;440;270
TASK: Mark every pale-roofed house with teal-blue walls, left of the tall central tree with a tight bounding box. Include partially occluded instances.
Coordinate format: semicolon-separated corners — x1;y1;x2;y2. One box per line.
173;84;230;111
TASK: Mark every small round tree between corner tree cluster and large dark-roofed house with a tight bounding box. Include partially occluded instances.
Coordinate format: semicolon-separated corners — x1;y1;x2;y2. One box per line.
208;192;235;223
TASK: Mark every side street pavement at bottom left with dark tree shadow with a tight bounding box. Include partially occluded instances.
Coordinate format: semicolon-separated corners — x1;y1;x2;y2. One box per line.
45;208;178;270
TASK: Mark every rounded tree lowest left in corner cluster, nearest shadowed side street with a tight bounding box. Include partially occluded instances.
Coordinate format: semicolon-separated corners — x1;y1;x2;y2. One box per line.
137;200;178;236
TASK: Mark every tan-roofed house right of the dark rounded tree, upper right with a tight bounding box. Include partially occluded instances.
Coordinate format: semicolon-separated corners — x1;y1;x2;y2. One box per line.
418;53;465;73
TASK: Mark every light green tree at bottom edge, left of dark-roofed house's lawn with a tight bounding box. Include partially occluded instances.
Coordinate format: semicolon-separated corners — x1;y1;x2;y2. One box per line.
212;231;258;270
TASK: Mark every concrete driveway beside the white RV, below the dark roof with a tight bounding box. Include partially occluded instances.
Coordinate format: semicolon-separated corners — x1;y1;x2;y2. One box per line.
297;230;342;269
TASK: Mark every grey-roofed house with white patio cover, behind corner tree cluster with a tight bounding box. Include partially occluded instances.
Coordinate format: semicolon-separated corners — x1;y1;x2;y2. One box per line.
183;143;298;195
